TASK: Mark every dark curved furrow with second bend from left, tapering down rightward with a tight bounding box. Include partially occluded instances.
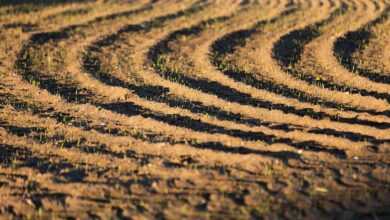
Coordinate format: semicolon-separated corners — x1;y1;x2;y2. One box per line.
83;32;276;130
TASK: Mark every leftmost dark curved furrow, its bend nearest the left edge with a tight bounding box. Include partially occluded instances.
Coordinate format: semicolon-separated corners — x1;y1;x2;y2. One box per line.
16;2;204;103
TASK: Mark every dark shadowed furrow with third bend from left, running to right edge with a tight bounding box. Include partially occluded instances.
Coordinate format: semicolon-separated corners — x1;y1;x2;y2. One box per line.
143;14;390;142
